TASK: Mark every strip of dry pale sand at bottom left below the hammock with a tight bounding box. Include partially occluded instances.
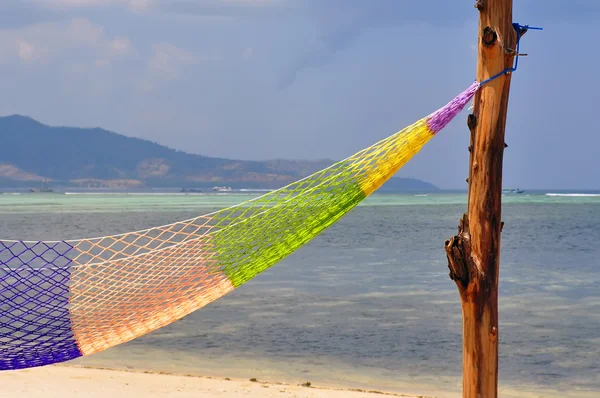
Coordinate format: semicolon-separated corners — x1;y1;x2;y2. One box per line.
0;366;436;398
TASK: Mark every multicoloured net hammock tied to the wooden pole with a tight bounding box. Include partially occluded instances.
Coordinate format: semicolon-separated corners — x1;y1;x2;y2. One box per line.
0;83;479;370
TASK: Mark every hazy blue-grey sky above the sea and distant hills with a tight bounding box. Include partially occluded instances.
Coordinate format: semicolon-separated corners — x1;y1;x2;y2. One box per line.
0;0;600;189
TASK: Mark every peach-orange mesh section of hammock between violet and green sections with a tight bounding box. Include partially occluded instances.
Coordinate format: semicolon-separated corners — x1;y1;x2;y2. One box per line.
70;219;234;355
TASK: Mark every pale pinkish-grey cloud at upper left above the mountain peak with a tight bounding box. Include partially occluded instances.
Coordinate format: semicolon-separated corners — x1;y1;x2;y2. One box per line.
0;18;132;63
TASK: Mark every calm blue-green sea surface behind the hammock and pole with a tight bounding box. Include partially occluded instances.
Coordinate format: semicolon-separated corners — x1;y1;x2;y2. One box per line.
0;192;600;397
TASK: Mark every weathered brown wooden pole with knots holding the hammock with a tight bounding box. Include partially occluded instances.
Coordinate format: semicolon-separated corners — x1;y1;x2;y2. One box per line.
446;0;518;398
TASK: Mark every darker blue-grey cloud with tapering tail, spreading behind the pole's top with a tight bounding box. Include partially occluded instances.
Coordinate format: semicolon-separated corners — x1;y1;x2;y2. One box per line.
279;0;600;88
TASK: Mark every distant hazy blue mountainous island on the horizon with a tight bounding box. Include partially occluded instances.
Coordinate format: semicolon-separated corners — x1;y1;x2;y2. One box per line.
0;115;438;192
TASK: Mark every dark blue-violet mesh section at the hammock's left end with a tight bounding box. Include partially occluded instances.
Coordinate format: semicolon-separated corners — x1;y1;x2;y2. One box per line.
0;241;81;370
